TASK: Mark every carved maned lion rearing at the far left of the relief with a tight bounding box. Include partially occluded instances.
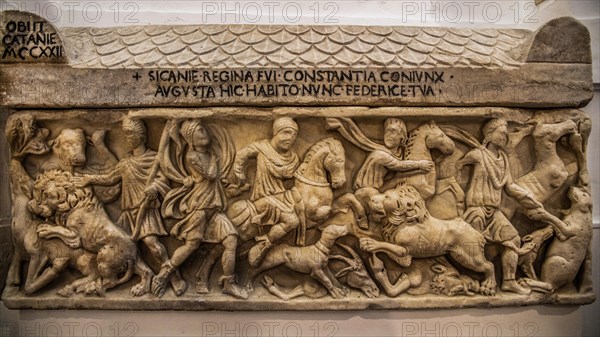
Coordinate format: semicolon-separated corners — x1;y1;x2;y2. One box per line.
29;170;153;296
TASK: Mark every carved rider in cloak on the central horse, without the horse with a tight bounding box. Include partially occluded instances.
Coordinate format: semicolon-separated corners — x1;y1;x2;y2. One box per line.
233;117;306;266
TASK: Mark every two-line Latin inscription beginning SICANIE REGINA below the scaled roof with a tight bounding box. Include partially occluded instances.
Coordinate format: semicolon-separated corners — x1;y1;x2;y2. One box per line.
143;69;446;98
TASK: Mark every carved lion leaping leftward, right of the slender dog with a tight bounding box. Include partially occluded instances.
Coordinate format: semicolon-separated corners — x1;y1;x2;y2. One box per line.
360;186;496;295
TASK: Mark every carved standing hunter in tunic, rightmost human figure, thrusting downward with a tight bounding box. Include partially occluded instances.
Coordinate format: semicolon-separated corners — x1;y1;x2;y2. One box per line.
457;118;568;294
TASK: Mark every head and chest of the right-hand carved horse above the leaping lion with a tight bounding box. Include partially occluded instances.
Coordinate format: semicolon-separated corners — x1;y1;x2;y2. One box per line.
381;121;455;200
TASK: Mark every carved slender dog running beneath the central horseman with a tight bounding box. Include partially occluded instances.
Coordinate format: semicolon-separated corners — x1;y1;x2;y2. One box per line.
246;225;349;298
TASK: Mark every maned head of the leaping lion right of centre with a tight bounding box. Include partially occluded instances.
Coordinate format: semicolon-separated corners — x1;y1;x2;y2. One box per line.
369;185;429;240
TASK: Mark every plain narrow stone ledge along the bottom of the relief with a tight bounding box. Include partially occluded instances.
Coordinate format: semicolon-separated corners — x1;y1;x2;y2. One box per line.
2;288;596;311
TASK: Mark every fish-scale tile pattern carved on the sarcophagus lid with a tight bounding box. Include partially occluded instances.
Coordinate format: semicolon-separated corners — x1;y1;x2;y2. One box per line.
63;25;531;68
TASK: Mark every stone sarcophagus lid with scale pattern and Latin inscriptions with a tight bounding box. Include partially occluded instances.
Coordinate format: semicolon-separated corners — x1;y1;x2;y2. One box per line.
0;11;593;108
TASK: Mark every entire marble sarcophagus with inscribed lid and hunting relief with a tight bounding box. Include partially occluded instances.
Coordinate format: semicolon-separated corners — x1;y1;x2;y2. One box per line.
0;12;595;310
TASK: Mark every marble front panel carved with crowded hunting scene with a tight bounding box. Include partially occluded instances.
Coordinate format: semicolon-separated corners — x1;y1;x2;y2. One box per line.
0;108;593;309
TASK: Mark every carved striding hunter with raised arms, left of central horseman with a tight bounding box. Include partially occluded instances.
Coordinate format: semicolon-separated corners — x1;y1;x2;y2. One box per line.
152;119;248;299
